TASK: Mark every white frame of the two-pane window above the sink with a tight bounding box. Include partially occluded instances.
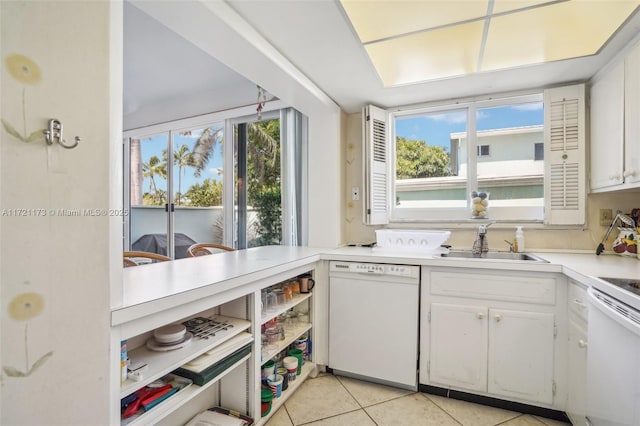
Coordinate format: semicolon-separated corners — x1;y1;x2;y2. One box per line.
387;90;546;223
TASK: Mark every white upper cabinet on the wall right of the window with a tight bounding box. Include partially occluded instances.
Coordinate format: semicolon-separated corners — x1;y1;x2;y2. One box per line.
590;43;640;192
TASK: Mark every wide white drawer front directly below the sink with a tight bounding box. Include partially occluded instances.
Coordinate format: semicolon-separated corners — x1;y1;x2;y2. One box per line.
429;271;556;305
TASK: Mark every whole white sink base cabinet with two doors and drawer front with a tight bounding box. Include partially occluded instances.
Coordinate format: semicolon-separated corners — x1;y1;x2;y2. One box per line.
420;267;566;408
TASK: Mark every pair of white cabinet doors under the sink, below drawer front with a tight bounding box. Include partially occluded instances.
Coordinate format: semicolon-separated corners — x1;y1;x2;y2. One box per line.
429;303;554;404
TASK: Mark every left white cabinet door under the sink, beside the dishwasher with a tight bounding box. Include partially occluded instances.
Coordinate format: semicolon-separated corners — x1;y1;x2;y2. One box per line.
429;303;487;392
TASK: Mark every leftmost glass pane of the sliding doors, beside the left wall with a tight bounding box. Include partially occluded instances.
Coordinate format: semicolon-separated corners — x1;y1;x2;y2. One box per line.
130;134;169;255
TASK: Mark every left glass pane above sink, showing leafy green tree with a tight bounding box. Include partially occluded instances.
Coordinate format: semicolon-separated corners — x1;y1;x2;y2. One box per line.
395;110;468;208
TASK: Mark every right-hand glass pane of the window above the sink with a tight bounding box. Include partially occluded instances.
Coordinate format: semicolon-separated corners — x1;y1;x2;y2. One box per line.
477;101;544;207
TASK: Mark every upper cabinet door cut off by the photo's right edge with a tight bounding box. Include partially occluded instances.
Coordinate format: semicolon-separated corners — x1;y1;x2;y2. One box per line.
624;43;640;186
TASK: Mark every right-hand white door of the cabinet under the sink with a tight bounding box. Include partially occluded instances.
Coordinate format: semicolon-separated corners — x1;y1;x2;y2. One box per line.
487;309;554;404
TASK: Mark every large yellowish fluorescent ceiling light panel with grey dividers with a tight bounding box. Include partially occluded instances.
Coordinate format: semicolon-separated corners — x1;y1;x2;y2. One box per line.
340;0;640;86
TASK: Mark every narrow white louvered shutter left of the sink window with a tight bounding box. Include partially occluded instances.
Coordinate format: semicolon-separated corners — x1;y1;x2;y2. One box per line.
363;105;389;225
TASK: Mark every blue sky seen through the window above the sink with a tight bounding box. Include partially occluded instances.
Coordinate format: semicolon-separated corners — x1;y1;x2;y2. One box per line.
395;102;543;152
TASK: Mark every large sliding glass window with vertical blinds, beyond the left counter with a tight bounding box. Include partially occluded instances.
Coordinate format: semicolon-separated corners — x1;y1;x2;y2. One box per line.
124;108;307;258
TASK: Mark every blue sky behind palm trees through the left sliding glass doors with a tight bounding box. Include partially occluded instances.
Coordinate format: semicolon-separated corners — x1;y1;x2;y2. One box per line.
140;125;223;193
